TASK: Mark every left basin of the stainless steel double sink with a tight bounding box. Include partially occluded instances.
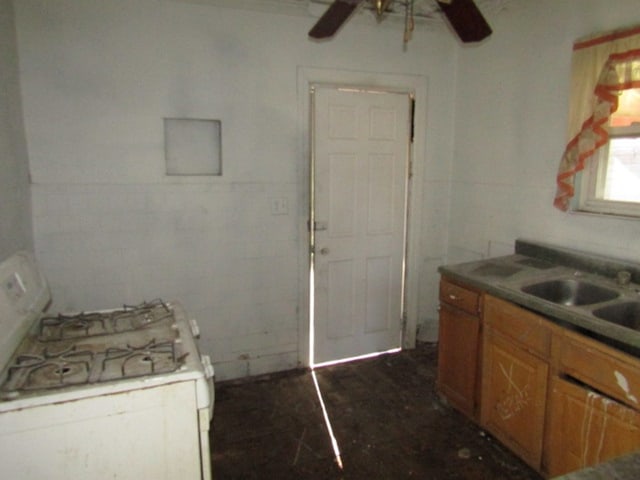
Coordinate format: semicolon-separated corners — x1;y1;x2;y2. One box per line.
521;278;619;305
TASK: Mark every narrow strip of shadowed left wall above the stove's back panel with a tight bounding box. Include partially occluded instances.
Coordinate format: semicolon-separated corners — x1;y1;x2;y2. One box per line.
0;0;33;260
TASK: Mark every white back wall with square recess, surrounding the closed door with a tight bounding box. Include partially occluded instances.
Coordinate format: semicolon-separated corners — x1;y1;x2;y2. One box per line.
15;0;456;379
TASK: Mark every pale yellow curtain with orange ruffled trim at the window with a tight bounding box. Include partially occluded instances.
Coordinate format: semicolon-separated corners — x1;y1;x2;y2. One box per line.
554;26;640;210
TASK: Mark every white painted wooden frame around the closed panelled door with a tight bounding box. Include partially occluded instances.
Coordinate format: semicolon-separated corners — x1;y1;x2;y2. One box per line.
296;66;427;366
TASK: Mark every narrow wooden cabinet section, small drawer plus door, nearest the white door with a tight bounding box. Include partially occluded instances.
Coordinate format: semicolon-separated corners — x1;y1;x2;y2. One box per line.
437;278;481;420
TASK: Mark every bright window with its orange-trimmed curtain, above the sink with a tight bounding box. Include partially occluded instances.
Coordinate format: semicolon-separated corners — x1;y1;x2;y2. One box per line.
553;25;640;212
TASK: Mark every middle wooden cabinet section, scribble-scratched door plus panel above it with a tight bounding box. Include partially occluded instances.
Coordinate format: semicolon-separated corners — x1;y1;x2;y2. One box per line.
480;295;553;470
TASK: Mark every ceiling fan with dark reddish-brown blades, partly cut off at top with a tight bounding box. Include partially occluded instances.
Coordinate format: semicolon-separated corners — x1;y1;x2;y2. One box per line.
309;0;491;43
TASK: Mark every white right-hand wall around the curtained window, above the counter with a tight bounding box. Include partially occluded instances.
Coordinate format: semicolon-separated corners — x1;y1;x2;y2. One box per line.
447;0;640;263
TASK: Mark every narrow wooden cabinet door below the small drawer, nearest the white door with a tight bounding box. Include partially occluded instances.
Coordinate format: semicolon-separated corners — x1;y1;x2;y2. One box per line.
438;303;480;418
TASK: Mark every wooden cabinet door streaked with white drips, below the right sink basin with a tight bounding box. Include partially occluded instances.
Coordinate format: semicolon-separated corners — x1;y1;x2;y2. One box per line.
545;378;640;476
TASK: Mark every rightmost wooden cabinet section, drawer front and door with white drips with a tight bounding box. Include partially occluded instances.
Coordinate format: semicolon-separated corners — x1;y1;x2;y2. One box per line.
544;332;640;476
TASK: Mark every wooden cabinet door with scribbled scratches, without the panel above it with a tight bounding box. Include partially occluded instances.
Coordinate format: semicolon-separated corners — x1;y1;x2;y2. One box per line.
481;329;549;469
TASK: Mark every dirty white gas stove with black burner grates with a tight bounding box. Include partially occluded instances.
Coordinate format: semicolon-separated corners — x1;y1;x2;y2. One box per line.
0;252;214;480
